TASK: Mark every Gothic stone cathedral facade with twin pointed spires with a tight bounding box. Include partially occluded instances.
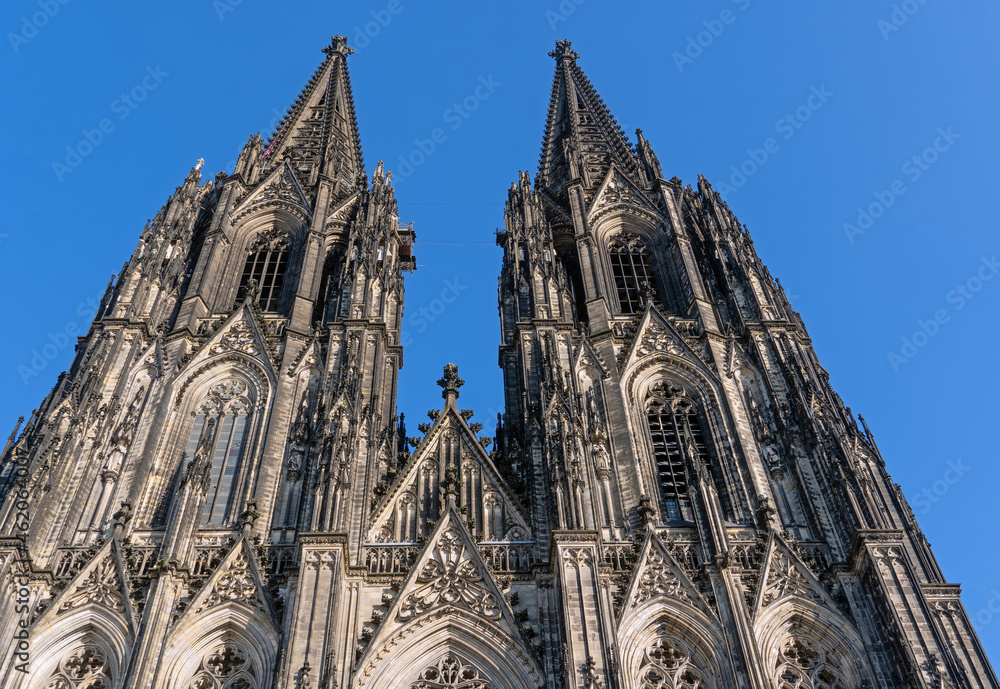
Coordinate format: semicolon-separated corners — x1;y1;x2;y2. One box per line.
0;36;1000;689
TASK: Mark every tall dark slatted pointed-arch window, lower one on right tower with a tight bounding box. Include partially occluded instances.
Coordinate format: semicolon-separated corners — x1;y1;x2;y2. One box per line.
646;384;708;521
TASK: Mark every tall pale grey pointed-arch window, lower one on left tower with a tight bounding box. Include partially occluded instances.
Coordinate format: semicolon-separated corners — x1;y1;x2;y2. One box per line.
187;379;251;526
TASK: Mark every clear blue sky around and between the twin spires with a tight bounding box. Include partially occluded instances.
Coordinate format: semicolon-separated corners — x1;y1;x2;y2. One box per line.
0;0;1000;657
